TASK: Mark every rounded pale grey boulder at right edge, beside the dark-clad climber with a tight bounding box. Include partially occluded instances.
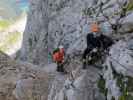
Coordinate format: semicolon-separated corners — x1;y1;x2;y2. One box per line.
110;39;133;76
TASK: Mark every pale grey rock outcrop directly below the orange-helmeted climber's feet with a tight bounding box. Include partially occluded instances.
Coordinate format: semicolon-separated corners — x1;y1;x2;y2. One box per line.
48;62;105;100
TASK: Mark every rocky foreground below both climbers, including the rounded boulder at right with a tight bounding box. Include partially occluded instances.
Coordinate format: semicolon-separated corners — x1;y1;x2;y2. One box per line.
0;39;133;100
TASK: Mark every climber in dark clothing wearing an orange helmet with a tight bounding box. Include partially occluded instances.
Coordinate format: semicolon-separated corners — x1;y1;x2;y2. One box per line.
82;21;113;69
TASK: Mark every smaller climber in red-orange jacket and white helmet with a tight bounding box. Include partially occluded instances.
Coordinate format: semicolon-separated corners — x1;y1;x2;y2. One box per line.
53;46;64;72
